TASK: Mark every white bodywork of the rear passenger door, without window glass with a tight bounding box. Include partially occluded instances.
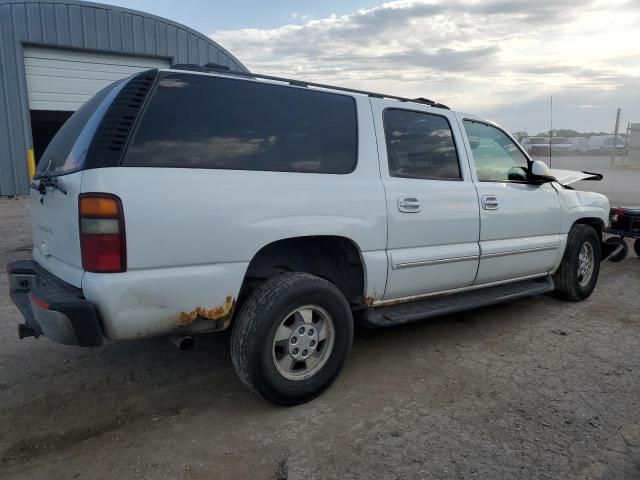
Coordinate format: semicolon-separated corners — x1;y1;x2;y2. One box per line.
371;98;480;300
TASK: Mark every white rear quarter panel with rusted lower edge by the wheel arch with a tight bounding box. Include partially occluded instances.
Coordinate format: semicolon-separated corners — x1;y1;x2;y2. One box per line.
82;96;387;338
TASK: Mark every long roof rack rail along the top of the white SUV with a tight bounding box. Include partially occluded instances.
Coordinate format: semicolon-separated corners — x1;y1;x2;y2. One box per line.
163;63;450;110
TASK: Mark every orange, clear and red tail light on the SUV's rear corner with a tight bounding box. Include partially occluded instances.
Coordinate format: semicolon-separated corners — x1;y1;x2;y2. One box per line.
79;193;127;273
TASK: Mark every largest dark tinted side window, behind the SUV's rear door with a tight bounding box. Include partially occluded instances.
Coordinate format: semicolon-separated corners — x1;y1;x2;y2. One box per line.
124;74;357;173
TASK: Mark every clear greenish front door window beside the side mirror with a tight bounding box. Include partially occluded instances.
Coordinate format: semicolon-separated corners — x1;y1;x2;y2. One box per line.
463;120;528;182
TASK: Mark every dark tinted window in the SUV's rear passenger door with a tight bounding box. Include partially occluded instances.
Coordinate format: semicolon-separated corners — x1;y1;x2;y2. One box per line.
384;109;462;180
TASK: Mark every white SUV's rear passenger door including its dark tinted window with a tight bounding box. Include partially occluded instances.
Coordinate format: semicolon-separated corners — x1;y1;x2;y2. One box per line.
371;98;479;299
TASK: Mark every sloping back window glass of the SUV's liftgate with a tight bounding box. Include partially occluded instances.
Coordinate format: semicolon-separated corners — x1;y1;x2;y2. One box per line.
34;80;125;178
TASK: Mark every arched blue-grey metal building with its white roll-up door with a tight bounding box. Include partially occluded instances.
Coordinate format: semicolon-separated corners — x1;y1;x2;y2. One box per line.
0;0;247;195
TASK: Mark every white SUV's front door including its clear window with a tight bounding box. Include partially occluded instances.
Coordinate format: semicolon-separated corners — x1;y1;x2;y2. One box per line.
459;115;561;284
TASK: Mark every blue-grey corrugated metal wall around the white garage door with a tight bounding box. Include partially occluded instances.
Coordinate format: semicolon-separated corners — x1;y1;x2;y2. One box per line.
0;0;247;195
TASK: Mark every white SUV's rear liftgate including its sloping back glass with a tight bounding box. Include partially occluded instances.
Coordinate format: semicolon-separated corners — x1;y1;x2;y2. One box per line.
30;81;124;287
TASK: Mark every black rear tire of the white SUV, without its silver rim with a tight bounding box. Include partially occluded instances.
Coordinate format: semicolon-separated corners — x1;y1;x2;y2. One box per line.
231;273;353;406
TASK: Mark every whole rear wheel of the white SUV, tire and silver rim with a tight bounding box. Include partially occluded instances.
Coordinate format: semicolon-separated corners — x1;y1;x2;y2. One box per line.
231;273;353;405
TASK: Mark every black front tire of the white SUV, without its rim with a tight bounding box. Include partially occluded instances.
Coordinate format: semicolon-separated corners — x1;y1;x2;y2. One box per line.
553;225;602;302
